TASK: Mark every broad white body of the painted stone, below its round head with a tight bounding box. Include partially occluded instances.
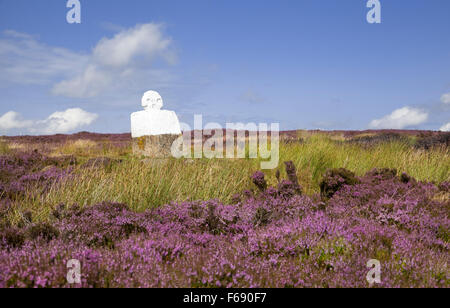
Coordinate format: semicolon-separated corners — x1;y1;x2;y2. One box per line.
131;109;181;138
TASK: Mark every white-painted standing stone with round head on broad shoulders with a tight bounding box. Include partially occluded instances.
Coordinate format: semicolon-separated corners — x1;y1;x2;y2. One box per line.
131;91;181;138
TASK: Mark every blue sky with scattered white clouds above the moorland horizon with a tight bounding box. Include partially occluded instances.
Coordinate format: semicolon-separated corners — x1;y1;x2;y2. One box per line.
0;0;450;135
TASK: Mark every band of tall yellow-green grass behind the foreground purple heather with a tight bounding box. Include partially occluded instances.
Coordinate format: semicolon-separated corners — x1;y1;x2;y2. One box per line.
7;134;450;223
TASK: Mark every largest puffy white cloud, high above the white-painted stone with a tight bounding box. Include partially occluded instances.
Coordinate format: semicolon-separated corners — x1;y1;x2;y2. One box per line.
52;23;176;98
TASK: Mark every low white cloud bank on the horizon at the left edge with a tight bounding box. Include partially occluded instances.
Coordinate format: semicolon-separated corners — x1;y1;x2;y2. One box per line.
0;108;98;134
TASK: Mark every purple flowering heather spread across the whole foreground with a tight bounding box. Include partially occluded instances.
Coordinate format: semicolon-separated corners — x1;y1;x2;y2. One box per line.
0;166;450;287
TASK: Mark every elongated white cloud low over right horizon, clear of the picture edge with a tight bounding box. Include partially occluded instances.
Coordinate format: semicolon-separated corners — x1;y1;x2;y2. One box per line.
369;106;428;129
